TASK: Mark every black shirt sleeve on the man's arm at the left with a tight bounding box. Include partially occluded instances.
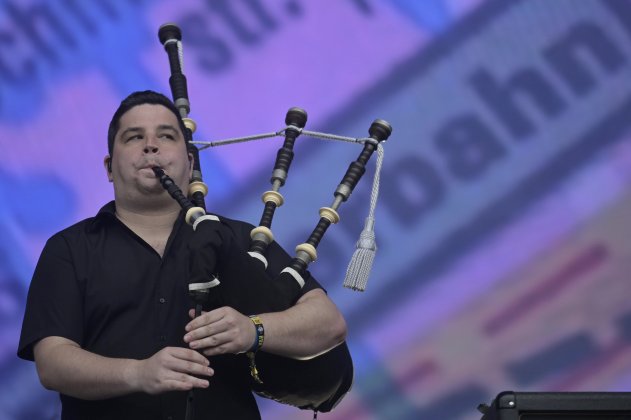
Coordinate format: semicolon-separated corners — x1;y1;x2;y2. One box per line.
18;234;83;360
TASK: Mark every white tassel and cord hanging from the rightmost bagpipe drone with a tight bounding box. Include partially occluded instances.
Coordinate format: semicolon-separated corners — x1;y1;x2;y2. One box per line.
344;143;383;292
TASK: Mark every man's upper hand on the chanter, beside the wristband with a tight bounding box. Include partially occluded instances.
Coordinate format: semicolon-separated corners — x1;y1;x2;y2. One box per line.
184;306;256;356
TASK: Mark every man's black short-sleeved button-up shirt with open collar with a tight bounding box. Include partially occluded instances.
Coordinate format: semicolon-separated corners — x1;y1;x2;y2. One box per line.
18;202;320;419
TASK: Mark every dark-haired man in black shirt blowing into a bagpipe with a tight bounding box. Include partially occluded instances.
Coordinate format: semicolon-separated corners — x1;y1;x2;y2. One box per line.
18;91;346;419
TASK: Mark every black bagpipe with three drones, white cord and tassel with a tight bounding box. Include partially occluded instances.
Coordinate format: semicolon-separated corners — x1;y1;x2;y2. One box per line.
154;24;392;412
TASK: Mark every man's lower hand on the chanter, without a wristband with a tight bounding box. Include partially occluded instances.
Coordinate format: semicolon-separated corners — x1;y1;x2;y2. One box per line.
134;347;214;394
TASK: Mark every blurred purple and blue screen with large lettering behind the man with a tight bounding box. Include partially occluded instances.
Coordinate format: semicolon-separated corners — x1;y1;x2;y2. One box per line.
0;0;631;420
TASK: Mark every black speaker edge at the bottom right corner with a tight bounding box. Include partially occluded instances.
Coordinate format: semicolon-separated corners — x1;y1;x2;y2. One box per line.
478;391;631;420
